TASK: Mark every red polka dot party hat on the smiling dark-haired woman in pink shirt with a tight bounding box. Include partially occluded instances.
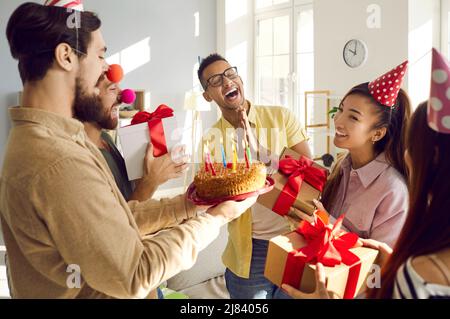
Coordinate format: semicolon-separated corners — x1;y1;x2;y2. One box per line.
369;61;408;107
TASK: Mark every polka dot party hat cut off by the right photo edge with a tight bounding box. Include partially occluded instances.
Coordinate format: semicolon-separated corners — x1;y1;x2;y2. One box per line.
428;49;450;134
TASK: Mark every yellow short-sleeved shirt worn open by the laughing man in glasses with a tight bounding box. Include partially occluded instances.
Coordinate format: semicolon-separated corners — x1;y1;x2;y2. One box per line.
204;103;307;278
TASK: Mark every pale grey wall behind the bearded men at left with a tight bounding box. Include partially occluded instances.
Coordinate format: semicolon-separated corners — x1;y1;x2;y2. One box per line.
0;0;217;192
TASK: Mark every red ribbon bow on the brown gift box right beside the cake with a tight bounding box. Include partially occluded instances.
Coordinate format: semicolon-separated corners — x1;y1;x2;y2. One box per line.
272;156;327;216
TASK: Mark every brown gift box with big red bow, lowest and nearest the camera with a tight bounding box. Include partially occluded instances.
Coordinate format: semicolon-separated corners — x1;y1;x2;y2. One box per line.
264;216;378;299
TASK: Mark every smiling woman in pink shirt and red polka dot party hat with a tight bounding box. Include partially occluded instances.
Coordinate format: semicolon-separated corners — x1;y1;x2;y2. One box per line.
322;63;411;250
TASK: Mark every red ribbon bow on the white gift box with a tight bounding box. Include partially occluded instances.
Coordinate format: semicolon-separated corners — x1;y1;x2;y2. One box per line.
131;104;173;157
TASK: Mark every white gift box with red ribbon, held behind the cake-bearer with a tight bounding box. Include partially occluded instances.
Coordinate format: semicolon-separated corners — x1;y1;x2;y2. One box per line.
118;105;182;181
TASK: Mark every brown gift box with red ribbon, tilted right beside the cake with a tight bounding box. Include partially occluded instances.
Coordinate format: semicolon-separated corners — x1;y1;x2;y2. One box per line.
258;148;328;218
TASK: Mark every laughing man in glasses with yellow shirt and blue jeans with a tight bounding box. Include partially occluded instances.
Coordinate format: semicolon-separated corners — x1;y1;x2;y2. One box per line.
198;54;311;299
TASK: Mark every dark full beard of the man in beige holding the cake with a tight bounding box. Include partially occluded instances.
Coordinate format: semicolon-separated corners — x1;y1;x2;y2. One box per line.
73;77;118;130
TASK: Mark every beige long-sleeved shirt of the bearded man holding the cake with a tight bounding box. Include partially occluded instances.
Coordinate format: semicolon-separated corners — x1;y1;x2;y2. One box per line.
0;108;223;298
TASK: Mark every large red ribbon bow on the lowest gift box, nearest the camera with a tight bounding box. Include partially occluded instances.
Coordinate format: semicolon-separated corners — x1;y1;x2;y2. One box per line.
283;215;361;299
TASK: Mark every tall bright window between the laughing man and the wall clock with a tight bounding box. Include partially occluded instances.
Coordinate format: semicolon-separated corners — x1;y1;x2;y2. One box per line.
255;0;314;123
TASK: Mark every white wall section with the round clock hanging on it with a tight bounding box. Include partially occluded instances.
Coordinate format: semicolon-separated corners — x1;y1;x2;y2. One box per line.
314;0;408;95
